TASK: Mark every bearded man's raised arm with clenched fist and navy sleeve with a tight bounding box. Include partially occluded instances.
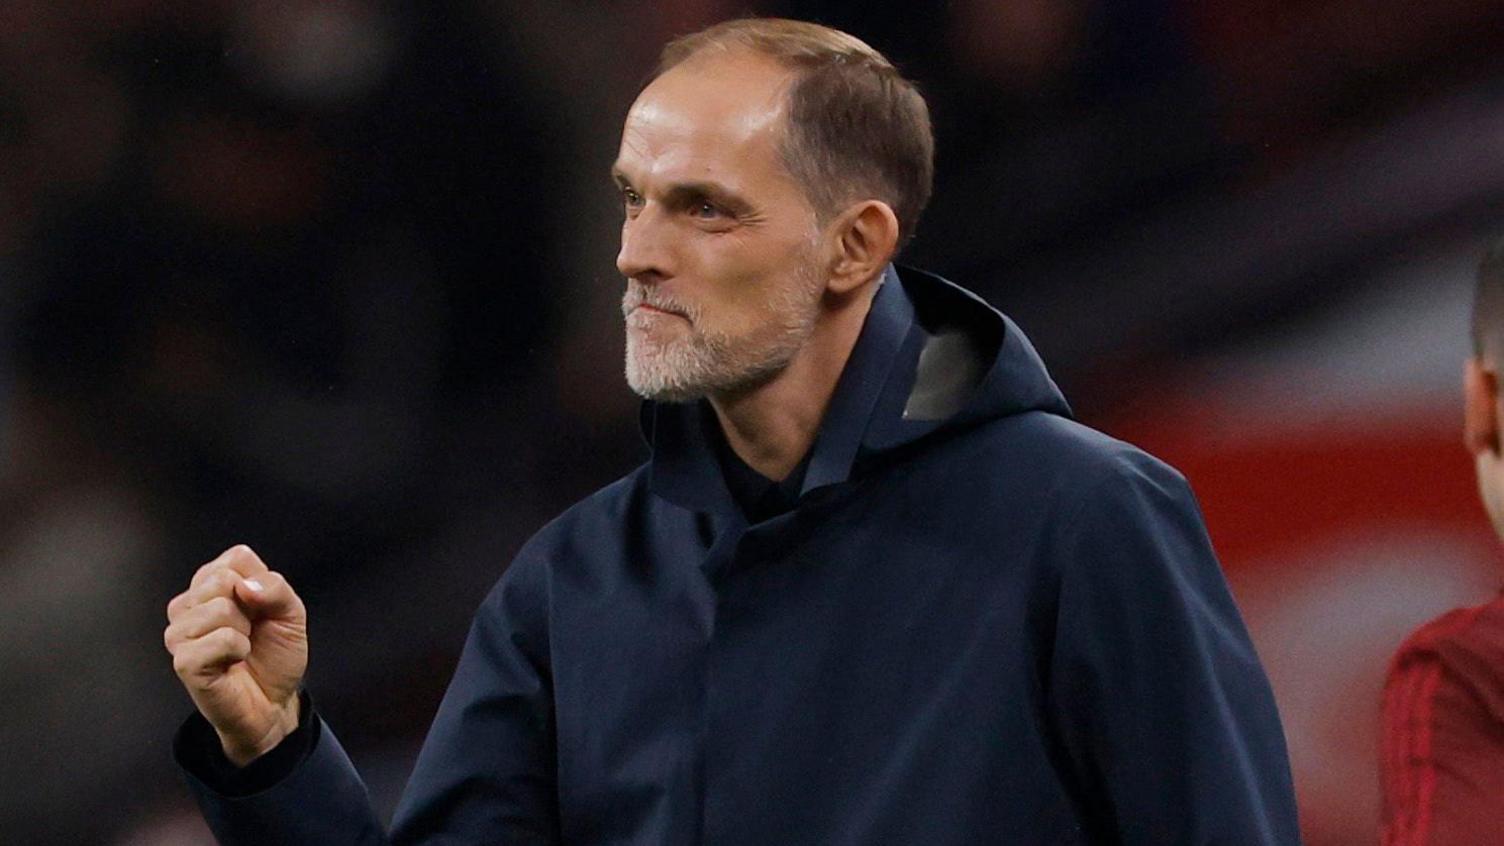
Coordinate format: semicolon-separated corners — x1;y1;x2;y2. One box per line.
165;546;559;846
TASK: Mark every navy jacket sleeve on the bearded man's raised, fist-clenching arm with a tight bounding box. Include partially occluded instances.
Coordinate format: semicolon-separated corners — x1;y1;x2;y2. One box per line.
177;541;558;846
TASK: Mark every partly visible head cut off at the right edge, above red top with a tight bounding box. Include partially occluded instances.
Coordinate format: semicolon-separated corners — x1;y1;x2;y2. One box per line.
1463;241;1504;536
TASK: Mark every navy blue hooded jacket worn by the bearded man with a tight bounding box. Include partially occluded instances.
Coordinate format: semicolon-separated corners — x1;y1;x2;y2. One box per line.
178;261;1298;846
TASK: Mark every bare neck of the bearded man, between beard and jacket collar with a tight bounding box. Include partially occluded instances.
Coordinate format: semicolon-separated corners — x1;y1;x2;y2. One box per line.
710;285;877;482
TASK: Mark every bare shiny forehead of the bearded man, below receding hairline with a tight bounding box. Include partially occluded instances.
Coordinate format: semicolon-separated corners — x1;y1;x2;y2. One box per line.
617;53;791;182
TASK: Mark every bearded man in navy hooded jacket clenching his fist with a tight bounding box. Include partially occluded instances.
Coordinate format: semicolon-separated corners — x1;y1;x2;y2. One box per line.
165;20;1298;846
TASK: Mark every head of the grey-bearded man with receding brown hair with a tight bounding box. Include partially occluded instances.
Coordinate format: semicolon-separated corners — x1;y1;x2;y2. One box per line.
614;20;934;400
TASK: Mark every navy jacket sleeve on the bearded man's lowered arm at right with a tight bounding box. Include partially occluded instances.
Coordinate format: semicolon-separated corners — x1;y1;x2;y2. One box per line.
1048;453;1299;846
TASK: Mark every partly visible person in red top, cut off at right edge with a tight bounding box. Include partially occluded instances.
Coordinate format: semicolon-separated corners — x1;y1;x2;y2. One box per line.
1381;241;1504;846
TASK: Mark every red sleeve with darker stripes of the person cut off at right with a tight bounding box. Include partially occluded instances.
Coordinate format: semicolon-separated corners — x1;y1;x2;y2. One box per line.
1381;605;1504;846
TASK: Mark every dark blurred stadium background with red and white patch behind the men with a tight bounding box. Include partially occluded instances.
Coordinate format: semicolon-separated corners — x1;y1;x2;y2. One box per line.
0;0;1504;846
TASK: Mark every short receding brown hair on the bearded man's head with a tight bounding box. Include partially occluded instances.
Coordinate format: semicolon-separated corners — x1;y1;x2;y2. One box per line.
657;18;935;245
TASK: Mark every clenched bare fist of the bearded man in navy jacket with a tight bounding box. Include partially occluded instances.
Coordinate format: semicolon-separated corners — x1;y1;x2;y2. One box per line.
162;545;308;766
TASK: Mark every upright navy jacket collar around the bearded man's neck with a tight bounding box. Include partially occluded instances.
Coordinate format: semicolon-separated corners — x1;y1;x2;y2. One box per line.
641;265;922;513
